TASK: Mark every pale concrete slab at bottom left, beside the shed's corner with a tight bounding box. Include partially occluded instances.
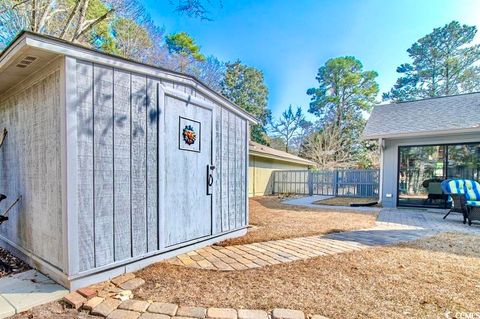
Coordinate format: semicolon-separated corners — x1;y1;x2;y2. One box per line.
0;269;68;318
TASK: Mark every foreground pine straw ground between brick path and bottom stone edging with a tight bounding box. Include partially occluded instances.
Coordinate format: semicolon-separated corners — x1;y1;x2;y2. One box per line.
134;234;480;318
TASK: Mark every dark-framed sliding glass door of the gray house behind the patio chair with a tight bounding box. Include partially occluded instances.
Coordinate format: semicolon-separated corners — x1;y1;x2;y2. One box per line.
398;143;480;208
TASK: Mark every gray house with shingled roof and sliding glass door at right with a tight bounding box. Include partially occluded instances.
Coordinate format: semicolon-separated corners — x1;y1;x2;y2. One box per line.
364;93;480;207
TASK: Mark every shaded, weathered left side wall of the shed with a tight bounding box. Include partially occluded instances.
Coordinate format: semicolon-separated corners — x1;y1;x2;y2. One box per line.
0;60;65;270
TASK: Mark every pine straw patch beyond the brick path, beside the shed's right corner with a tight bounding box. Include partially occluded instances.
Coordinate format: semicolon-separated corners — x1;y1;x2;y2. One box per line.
218;196;377;246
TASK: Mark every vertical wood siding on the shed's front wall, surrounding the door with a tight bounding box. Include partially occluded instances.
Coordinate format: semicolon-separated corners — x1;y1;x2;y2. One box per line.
74;60;248;272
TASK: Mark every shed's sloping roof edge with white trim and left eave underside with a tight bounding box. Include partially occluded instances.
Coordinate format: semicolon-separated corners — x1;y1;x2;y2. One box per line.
0;31;258;123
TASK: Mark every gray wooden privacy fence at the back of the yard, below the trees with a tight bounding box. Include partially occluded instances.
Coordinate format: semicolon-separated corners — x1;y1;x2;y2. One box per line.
272;169;380;197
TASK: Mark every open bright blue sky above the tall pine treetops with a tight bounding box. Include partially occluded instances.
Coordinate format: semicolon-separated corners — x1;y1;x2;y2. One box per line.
143;0;480;116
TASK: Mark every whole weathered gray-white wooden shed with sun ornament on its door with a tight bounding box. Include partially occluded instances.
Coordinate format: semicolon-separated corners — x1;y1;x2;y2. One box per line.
0;32;255;289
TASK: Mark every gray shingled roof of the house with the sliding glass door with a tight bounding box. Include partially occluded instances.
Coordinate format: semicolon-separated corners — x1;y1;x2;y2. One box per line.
363;92;480;139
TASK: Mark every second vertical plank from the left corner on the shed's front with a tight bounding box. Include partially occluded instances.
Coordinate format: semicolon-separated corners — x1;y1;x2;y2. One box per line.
93;65;114;267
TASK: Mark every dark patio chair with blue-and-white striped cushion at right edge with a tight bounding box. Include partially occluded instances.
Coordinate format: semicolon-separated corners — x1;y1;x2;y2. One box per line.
442;179;480;225
